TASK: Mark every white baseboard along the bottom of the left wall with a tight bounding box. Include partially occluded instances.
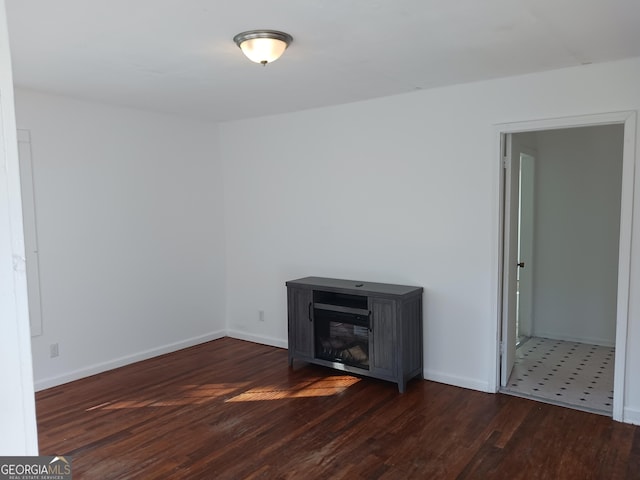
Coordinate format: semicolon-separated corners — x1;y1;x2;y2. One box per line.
34;330;226;392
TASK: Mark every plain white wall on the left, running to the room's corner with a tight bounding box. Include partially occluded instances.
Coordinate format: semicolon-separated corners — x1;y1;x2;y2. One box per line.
16;89;225;389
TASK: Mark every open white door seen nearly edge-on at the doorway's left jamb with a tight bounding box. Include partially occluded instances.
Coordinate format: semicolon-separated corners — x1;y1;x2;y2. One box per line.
500;133;521;387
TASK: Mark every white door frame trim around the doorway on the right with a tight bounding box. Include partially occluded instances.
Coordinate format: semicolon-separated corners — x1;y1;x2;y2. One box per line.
496;111;636;422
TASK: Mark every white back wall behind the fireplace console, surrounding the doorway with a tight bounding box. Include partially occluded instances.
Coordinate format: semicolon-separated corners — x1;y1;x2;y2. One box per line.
220;59;640;422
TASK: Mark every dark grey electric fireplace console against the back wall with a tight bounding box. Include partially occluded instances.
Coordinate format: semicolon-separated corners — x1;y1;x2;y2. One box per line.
286;277;423;393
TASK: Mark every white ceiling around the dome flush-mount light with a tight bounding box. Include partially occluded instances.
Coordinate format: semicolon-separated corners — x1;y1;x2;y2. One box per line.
6;0;640;121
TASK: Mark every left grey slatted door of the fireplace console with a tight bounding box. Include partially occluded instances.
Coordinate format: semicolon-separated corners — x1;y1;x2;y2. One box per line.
287;287;314;365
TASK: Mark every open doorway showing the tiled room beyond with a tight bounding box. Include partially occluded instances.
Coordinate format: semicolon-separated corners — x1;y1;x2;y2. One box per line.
499;111;635;419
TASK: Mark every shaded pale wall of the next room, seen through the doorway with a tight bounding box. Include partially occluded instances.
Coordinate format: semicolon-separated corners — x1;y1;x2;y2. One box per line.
533;125;624;346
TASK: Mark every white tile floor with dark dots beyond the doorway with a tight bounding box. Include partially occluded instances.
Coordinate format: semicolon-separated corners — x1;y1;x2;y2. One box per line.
504;337;615;415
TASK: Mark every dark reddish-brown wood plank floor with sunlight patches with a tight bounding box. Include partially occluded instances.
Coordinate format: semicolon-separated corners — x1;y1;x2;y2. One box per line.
36;338;640;480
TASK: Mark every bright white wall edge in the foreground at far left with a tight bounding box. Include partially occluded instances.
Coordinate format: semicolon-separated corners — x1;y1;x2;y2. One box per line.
0;0;38;456
